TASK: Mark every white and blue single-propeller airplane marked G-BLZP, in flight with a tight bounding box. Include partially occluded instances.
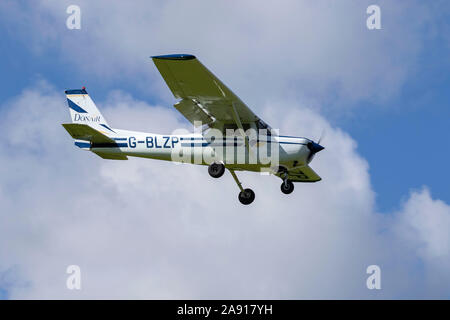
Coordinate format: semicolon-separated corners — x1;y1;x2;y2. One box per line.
62;54;324;205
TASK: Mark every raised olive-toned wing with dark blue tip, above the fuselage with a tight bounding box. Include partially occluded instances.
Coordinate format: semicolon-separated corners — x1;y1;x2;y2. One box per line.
152;54;267;128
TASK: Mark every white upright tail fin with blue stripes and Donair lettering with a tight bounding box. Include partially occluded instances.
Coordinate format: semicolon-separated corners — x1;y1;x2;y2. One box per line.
65;87;115;134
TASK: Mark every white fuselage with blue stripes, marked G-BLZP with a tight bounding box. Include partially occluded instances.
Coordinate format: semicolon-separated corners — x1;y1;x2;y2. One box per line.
87;129;311;171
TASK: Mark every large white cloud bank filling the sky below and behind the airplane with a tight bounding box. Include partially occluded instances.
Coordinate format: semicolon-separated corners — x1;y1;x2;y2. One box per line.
0;83;450;298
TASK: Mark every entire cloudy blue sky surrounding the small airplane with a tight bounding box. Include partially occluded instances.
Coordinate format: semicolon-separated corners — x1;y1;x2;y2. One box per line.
0;0;450;299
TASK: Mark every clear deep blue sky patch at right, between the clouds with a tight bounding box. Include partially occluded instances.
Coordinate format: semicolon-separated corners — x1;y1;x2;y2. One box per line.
344;48;450;211
